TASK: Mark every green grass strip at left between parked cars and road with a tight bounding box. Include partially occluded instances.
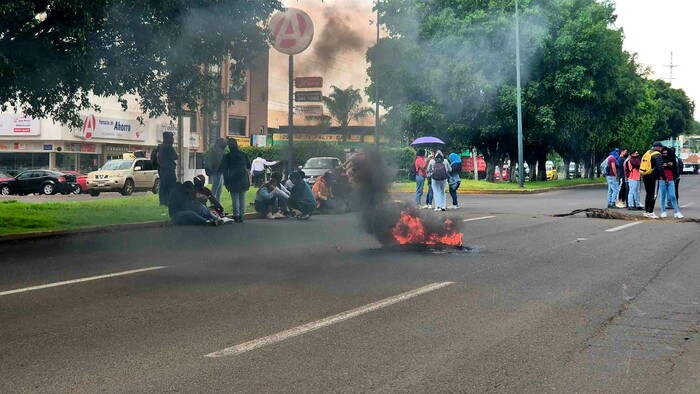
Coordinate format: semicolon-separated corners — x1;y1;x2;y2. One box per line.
0;190;255;235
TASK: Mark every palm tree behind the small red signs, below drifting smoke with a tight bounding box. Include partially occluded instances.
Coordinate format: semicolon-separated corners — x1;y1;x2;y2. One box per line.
310;86;374;140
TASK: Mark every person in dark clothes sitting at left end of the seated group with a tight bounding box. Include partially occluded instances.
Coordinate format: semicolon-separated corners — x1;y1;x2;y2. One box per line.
168;181;223;226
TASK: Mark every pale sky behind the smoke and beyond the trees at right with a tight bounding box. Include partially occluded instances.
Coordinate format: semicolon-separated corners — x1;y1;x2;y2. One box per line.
270;0;700;127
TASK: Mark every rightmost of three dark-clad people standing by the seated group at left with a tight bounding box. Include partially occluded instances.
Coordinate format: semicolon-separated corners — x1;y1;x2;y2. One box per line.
221;138;250;223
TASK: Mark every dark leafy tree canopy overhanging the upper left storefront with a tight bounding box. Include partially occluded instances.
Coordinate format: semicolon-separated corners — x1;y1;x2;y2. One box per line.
0;0;281;125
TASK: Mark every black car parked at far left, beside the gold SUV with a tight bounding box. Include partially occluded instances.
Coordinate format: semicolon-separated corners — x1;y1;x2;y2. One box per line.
0;170;79;196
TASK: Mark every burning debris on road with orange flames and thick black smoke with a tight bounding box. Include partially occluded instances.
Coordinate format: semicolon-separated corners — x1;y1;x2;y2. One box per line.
354;151;467;250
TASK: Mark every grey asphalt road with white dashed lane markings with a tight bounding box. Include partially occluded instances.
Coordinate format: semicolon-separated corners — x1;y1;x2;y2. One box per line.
0;176;700;393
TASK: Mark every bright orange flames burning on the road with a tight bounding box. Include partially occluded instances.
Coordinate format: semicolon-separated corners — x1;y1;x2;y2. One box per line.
392;210;464;246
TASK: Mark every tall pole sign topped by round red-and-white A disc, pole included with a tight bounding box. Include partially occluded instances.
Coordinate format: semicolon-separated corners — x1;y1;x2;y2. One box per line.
270;8;314;174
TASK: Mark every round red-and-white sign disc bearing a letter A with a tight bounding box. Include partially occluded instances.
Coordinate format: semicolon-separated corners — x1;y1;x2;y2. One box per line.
270;8;314;55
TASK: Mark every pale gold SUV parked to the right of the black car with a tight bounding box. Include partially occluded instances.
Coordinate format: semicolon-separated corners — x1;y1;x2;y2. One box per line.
86;158;160;197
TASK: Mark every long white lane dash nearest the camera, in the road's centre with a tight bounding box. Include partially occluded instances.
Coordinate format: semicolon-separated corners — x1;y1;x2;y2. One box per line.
204;282;454;357
